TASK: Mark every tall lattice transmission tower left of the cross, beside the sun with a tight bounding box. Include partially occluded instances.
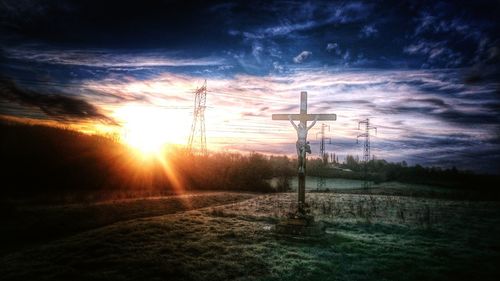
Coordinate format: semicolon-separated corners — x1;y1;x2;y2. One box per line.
188;80;207;155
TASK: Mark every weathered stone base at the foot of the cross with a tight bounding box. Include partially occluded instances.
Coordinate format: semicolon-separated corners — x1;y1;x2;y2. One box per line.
275;215;325;237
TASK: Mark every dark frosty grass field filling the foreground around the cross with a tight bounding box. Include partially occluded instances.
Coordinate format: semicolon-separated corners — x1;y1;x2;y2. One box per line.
0;189;500;280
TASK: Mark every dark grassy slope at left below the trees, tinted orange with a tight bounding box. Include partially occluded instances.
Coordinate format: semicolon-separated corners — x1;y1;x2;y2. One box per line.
0;192;256;255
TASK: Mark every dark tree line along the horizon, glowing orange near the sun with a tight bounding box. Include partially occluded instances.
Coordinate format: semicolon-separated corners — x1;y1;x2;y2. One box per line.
0;122;498;199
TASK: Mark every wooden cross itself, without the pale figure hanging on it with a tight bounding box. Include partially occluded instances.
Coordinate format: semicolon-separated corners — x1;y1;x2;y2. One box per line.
272;92;337;214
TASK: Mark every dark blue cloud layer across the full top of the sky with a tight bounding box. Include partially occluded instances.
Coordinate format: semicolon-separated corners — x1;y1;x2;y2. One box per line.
0;0;500;72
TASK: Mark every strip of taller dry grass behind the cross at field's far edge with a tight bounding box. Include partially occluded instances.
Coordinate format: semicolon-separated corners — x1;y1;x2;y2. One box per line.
217;193;500;227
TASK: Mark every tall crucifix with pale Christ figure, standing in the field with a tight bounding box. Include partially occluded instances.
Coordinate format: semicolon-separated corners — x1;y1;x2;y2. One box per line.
272;92;337;215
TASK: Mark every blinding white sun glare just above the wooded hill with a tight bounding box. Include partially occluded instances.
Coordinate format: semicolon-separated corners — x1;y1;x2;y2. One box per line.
115;105;185;155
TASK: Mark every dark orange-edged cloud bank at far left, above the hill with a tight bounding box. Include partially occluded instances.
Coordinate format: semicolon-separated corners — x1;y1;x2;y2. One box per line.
0;78;115;124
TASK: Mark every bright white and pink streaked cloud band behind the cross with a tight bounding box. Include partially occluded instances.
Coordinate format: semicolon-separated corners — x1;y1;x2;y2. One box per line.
39;69;492;171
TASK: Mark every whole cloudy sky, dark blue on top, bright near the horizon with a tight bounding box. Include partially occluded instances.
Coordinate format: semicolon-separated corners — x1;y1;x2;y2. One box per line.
0;0;500;173
